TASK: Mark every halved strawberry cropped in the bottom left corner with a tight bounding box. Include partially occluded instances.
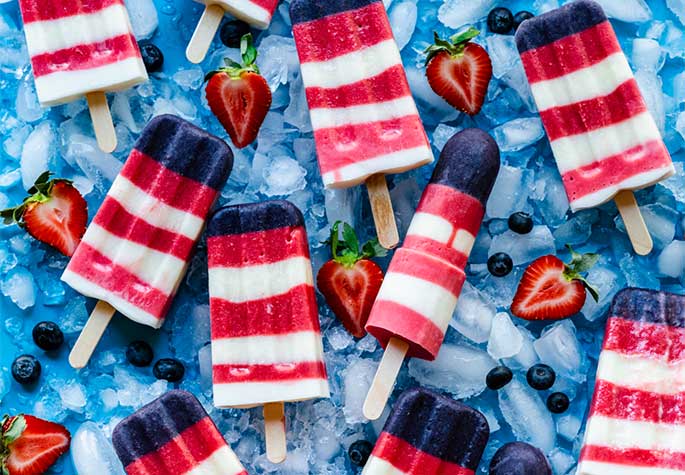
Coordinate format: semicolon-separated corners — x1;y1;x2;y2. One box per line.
0;415;71;475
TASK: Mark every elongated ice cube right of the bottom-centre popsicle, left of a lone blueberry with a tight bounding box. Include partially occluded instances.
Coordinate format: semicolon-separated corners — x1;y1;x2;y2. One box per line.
497;377;556;453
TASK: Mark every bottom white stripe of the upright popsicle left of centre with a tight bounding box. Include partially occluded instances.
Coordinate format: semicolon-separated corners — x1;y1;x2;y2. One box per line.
214;378;329;407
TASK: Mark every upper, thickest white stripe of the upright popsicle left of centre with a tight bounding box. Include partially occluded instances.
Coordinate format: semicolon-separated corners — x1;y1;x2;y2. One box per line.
209;256;314;303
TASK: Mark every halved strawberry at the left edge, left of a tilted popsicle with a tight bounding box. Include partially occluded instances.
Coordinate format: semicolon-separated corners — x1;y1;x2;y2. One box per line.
0;172;88;256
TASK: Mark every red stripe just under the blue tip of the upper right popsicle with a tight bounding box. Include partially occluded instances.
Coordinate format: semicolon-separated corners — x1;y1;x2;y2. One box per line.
521;21;622;84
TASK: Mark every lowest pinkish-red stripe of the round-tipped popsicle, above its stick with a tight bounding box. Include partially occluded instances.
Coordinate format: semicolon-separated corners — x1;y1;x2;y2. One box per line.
366;300;445;360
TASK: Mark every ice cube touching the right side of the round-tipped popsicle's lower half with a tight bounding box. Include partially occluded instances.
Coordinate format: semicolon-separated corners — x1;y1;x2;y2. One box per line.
450;282;497;343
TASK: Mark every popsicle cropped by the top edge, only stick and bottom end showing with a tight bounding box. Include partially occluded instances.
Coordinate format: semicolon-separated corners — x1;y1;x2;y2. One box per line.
186;0;278;63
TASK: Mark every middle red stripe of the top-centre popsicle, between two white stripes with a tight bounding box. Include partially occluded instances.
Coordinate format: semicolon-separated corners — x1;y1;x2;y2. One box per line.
305;64;411;109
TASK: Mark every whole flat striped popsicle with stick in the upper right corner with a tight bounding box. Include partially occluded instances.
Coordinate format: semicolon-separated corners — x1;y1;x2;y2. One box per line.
516;0;675;254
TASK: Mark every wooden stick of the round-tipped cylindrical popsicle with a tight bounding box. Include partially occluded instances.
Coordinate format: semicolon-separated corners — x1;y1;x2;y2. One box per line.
362;337;409;421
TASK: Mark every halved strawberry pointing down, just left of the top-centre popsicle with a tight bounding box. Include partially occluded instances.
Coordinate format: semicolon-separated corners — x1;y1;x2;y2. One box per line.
205;33;271;148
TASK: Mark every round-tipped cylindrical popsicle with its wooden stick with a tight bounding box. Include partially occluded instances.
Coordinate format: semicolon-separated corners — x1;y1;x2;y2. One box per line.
364;129;499;419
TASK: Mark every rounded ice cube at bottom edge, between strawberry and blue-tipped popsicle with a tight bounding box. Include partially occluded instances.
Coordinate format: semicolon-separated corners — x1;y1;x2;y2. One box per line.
70;421;126;475
